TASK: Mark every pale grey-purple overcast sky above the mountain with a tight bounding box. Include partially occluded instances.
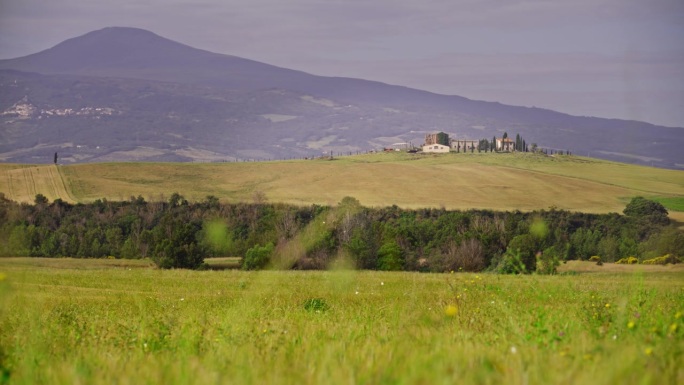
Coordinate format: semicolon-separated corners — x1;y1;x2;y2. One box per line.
0;0;684;127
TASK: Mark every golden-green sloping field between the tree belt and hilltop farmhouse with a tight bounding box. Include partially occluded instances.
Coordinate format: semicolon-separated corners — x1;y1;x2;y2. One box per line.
0;153;684;213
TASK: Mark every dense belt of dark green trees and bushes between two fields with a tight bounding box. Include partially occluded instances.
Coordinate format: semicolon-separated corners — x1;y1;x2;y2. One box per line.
0;193;684;273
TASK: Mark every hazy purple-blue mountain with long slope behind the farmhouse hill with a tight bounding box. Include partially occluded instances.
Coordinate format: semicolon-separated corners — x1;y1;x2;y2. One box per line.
0;27;684;168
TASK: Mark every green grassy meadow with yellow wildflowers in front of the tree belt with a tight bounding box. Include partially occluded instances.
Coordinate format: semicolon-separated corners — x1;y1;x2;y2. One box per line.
0;258;684;384
